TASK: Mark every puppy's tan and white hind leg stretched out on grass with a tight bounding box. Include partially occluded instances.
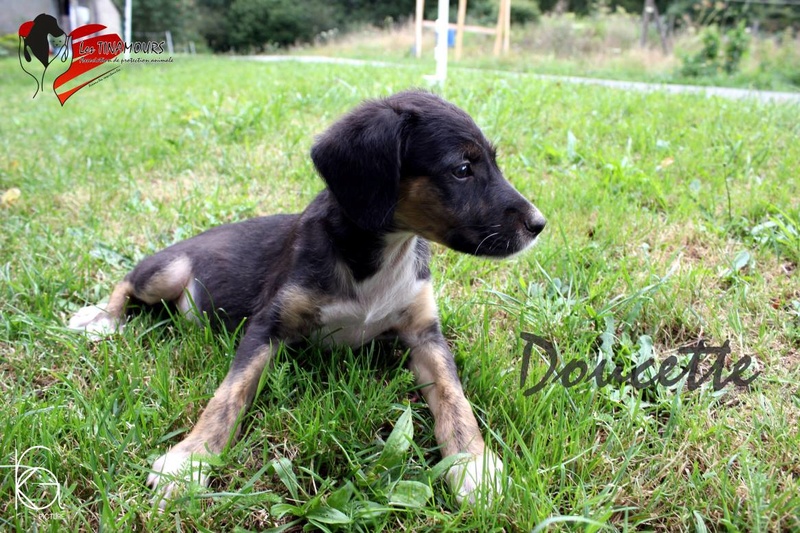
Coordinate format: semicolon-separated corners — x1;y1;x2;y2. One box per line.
68;252;193;339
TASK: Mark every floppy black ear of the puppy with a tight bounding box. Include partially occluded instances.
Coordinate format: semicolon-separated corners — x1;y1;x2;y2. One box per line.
311;102;403;231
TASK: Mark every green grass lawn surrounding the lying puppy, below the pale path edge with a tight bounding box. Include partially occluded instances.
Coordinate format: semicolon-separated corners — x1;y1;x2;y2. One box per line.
0;53;800;531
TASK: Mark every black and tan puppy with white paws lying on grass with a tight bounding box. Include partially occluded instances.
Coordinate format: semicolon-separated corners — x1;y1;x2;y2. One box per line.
70;91;545;505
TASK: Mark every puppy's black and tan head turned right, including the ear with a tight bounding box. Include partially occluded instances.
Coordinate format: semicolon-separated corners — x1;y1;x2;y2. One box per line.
311;91;545;257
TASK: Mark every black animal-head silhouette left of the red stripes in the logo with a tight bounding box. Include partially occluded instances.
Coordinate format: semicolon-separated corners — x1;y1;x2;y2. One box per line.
19;13;72;98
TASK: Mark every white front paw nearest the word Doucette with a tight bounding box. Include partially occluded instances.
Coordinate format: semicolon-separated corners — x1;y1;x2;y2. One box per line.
445;450;503;505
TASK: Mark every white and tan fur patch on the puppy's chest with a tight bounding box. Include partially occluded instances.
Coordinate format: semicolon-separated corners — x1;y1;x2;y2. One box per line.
320;238;424;348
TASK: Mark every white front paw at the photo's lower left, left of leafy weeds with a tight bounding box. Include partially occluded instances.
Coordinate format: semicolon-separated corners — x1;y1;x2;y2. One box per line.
147;451;208;510
